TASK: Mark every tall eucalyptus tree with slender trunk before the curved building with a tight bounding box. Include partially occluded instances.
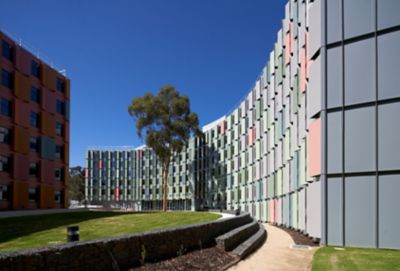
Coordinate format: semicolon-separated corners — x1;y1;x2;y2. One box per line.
128;85;202;211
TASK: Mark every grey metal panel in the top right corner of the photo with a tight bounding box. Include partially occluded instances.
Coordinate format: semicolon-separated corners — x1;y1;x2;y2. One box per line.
377;0;400;30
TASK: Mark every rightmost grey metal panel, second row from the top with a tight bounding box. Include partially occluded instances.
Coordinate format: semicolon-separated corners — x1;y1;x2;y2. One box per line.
378;30;400;99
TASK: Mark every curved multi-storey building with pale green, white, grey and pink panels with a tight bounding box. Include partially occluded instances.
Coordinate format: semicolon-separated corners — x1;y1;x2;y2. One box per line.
87;0;400;249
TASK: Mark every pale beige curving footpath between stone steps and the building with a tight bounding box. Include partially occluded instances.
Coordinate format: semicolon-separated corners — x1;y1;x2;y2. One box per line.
228;224;318;271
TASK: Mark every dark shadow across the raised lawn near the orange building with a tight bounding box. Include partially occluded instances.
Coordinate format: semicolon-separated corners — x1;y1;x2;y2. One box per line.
0;212;132;243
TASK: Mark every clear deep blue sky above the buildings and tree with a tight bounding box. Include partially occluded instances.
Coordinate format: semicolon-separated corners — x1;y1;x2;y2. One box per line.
0;0;286;166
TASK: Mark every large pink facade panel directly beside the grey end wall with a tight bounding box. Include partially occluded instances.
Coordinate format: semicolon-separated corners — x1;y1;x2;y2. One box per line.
307;118;321;177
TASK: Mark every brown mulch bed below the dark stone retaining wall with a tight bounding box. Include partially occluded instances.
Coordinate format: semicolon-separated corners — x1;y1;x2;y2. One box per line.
129;246;238;271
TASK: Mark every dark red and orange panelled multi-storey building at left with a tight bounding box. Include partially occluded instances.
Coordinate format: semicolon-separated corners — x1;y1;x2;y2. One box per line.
0;32;70;210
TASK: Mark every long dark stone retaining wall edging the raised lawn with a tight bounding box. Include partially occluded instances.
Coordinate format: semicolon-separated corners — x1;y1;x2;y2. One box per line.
0;214;252;271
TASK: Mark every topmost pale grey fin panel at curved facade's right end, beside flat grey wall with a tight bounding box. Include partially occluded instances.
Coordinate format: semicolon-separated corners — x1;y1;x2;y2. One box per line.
307;1;322;58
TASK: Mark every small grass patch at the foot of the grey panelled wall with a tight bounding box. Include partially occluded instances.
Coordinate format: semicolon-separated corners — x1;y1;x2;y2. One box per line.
312;247;400;271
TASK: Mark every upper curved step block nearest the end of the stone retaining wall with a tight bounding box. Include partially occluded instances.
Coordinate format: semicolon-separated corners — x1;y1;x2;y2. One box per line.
215;220;260;251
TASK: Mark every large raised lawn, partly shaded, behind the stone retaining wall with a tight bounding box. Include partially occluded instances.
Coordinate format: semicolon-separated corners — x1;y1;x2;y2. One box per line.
0;212;220;254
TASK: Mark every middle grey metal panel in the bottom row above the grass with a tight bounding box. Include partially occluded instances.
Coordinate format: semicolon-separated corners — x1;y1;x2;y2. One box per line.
345;176;376;247
